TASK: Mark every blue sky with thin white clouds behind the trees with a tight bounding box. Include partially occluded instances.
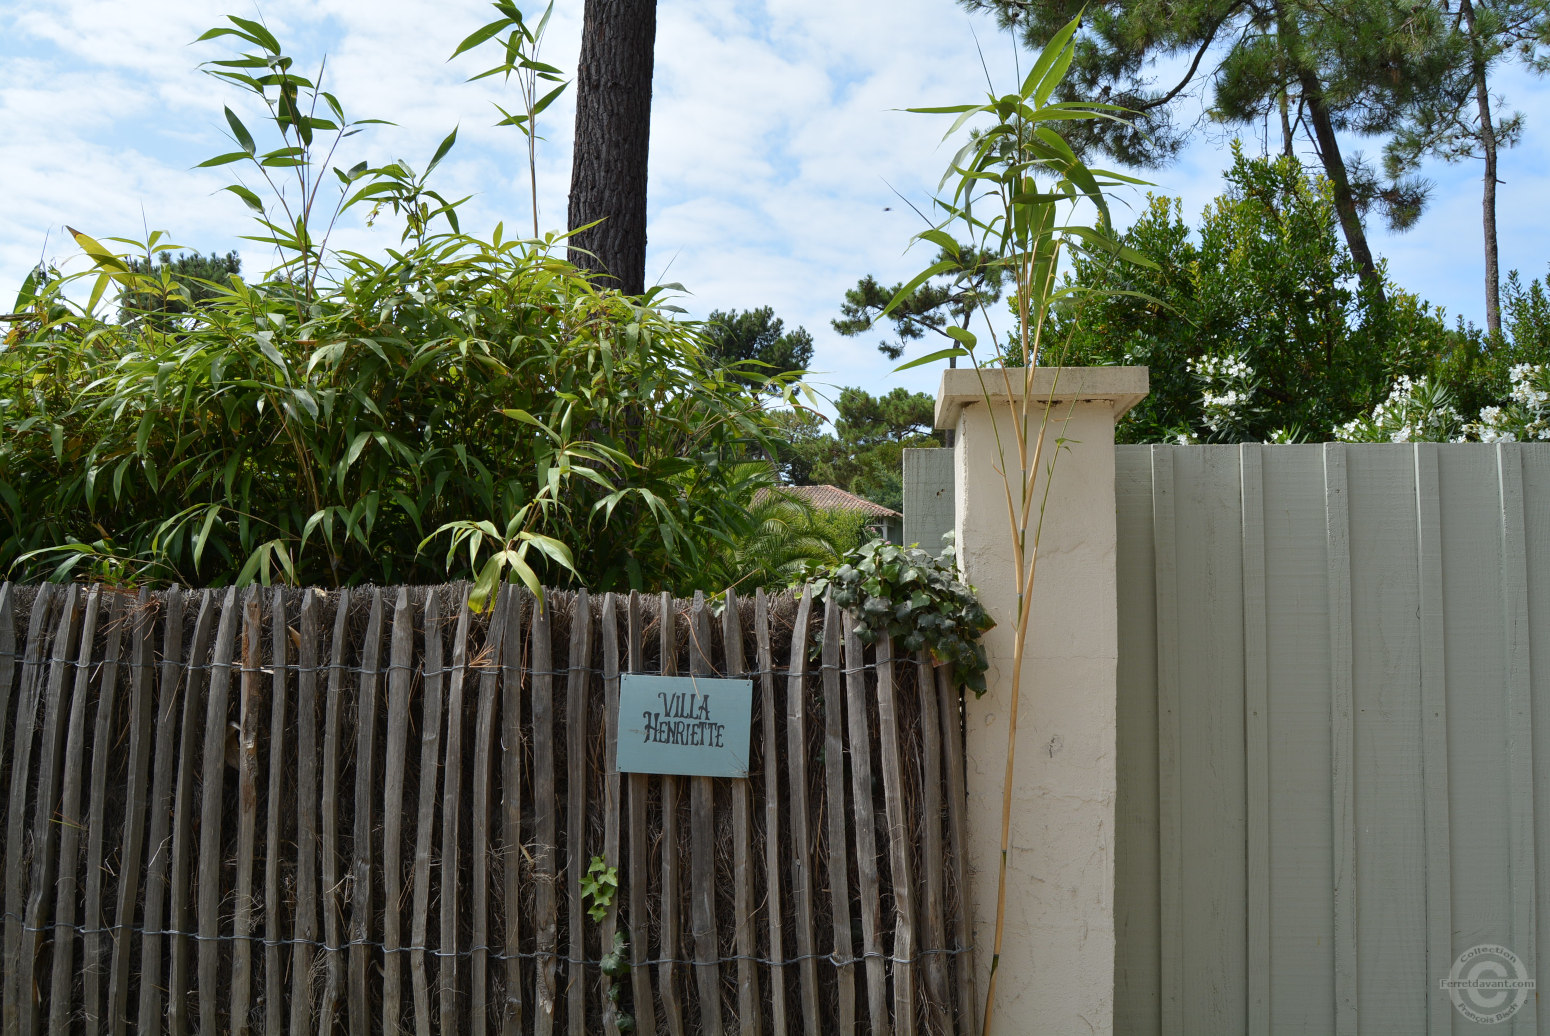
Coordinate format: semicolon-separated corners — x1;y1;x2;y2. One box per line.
0;0;1550;409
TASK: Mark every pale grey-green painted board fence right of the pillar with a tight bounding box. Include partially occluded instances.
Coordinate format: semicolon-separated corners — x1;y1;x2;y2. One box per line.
1114;444;1550;1036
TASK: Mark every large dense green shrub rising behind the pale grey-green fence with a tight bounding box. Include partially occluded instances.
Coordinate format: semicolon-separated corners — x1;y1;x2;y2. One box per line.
1059;144;1451;442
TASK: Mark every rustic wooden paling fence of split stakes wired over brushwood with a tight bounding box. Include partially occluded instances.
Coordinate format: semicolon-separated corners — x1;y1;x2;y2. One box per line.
0;585;973;1036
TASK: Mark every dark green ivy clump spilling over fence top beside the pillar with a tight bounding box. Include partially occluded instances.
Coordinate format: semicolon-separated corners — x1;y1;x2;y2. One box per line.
811;540;995;695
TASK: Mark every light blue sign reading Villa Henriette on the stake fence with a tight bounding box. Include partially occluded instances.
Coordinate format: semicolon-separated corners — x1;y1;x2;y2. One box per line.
615;673;753;777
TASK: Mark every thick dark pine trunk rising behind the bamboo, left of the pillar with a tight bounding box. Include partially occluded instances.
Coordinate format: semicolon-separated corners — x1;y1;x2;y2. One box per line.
569;0;657;295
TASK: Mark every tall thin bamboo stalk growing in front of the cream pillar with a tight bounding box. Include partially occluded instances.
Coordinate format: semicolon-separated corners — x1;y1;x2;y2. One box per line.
882;16;1152;1033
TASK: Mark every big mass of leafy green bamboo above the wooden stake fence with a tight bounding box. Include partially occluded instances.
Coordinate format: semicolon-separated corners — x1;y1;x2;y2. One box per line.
0;19;793;597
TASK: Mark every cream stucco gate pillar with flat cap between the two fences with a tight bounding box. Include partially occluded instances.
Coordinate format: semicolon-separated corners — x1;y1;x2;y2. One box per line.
936;368;1147;1034
